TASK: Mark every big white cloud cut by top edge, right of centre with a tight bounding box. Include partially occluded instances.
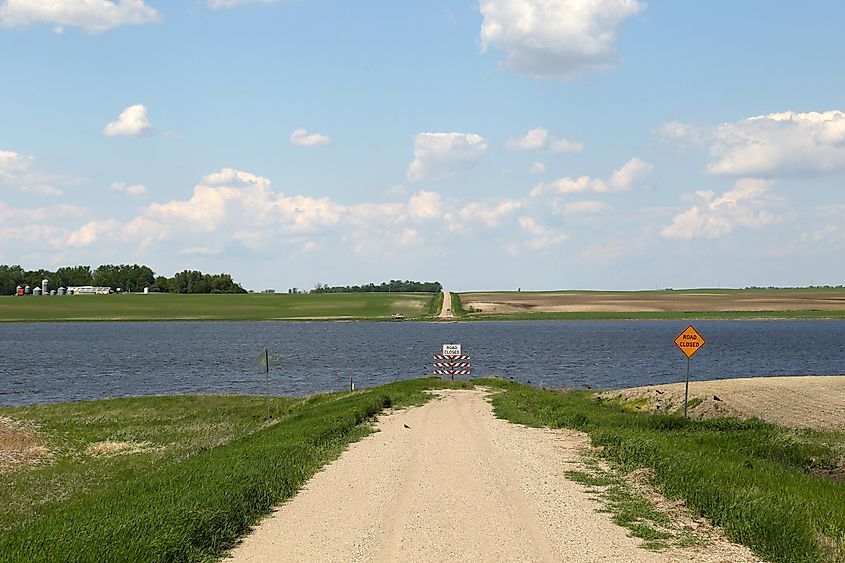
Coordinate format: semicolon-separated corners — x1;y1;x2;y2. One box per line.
480;0;643;78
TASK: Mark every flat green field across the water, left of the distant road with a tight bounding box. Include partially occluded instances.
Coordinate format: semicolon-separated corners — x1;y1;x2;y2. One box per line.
0;293;435;321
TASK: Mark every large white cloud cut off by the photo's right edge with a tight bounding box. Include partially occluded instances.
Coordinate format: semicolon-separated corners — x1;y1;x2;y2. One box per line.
657;110;845;177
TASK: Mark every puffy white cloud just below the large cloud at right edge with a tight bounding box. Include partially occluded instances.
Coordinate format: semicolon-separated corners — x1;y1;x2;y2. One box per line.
660;178;780;239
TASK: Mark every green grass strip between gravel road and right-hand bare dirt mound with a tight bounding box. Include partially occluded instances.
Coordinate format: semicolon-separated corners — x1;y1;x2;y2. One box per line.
476;379;845;562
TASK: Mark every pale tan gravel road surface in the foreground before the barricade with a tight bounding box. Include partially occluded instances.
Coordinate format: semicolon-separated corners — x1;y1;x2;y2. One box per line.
227;391;756;563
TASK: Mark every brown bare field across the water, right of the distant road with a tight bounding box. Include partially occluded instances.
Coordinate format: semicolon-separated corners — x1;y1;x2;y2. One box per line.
461;290;845;314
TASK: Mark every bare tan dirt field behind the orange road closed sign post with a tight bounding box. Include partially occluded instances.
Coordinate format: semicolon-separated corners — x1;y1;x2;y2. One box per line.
601;375;845;432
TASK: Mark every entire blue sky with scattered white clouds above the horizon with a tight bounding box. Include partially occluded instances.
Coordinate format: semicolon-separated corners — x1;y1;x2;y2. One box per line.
0;0;845;290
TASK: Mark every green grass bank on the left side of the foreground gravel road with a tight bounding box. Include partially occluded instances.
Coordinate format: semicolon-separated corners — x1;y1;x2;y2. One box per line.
0;378;468;562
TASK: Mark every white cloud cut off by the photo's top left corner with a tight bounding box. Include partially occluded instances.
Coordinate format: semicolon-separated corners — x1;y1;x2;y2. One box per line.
0;0;161;33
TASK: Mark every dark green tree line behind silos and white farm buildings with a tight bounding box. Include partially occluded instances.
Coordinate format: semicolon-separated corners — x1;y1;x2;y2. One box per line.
0;264;246;295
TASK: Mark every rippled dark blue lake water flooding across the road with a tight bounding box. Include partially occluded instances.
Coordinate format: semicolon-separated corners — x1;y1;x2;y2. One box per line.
0;320;845;405
